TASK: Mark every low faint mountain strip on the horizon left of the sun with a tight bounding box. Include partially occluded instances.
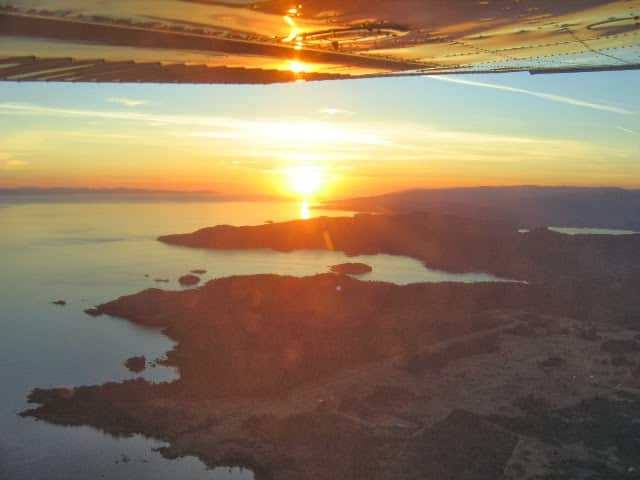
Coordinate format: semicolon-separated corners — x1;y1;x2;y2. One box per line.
0;187;273;203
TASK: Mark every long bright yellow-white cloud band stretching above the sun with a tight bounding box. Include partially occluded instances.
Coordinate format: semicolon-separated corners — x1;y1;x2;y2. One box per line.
0;102;633;168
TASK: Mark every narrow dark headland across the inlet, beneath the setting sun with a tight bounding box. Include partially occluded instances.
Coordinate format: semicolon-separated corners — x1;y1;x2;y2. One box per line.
159;213;640;281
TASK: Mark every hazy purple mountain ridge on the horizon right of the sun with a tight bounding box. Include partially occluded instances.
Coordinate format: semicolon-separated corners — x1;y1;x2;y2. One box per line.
325;186;640;230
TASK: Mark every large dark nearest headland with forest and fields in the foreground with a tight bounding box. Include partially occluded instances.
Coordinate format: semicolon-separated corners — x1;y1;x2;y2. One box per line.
24;274;640;480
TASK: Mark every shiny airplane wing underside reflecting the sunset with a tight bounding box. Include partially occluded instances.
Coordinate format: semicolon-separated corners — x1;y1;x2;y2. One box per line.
0;0;640;83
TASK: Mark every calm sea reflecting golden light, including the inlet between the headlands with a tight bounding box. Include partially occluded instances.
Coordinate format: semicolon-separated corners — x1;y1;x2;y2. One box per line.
0;203;504;480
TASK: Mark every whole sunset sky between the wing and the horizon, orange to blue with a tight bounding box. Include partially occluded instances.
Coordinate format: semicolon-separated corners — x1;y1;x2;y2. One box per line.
0;72;640;200
